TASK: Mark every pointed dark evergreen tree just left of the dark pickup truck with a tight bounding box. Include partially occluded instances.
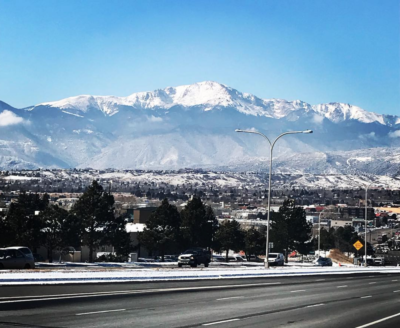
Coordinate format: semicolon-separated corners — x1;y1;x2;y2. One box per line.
139;198;181;262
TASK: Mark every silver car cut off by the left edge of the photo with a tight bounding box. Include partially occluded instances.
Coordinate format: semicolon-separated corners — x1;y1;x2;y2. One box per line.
0;246;35;269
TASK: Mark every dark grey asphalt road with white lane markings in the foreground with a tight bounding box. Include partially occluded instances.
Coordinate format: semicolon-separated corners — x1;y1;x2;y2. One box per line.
0;273;400;328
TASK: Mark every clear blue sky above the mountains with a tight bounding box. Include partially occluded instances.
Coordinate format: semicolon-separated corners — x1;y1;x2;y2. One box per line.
0;0;400;115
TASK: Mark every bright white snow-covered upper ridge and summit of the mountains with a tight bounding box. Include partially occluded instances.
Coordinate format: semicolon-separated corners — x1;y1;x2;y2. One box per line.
32;81;400;125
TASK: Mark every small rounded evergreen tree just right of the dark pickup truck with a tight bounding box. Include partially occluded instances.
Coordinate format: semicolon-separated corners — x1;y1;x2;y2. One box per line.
214;220;245;262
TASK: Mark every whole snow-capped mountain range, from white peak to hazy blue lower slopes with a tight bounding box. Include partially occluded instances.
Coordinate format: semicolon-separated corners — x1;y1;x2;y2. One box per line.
0;81;400;169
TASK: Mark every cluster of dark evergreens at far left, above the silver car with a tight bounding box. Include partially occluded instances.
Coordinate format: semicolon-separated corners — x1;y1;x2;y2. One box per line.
0;181;131;262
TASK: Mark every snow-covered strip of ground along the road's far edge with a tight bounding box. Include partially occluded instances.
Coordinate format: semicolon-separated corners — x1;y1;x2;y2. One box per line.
0;264;400;285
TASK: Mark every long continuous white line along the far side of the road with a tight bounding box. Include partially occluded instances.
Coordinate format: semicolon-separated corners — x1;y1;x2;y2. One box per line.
0;282;281;304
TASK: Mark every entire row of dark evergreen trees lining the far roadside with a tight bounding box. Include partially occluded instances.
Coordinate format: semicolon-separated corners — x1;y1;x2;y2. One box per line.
0;181;357;262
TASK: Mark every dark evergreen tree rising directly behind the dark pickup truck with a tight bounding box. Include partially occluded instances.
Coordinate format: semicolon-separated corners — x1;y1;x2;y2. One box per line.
181;196;218;248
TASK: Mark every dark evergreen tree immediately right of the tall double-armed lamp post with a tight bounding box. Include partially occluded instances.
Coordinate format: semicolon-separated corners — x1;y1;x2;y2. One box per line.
271;199;311;263
